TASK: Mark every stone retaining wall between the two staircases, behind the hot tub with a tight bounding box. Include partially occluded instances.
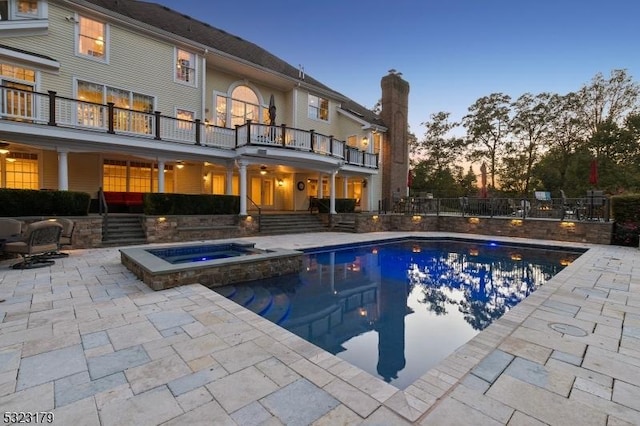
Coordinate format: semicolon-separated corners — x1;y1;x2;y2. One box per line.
142;215;258;244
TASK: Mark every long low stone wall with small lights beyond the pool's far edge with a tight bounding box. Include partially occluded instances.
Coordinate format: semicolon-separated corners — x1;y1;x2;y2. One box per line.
332;214;614;244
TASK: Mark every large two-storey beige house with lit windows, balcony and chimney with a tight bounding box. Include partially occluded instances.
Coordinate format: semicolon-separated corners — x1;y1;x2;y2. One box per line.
0;0;409;215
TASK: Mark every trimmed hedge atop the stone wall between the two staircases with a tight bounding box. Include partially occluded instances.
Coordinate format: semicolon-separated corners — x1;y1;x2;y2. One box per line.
143;193;240;216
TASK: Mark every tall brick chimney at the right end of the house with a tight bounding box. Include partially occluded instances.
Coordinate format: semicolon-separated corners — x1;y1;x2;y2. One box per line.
380;70;409;201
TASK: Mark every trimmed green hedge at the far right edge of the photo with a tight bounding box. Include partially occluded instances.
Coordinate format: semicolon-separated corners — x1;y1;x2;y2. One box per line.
611;194;640;247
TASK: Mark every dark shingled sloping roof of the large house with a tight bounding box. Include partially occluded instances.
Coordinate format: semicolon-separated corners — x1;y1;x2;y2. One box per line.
77;0;383;125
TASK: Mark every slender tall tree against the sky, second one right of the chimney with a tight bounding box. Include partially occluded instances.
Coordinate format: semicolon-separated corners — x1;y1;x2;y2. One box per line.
462;93;511;188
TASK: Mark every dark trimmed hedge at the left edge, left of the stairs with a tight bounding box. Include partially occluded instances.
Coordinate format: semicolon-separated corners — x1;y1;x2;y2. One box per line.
0;189;91;217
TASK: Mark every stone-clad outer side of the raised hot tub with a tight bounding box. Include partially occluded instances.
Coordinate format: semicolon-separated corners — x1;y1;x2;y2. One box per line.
120;253;302;290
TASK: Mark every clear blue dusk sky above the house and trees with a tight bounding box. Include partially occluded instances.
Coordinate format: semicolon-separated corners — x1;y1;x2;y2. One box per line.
152;0;640;139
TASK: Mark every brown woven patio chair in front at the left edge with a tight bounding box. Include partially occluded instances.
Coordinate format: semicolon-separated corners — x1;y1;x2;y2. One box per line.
4;220;62;269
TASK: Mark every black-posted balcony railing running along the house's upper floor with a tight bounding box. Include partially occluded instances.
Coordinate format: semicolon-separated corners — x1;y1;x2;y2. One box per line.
0;86;378;169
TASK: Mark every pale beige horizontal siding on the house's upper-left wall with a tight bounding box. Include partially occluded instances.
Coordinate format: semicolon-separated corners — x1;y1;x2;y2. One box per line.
2;3;202;116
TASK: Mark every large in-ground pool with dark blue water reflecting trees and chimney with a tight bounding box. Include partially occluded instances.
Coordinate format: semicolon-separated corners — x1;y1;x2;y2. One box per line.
216;239;583;389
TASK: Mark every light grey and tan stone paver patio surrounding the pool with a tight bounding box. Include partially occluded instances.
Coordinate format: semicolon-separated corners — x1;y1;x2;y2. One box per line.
0;232;640;425
